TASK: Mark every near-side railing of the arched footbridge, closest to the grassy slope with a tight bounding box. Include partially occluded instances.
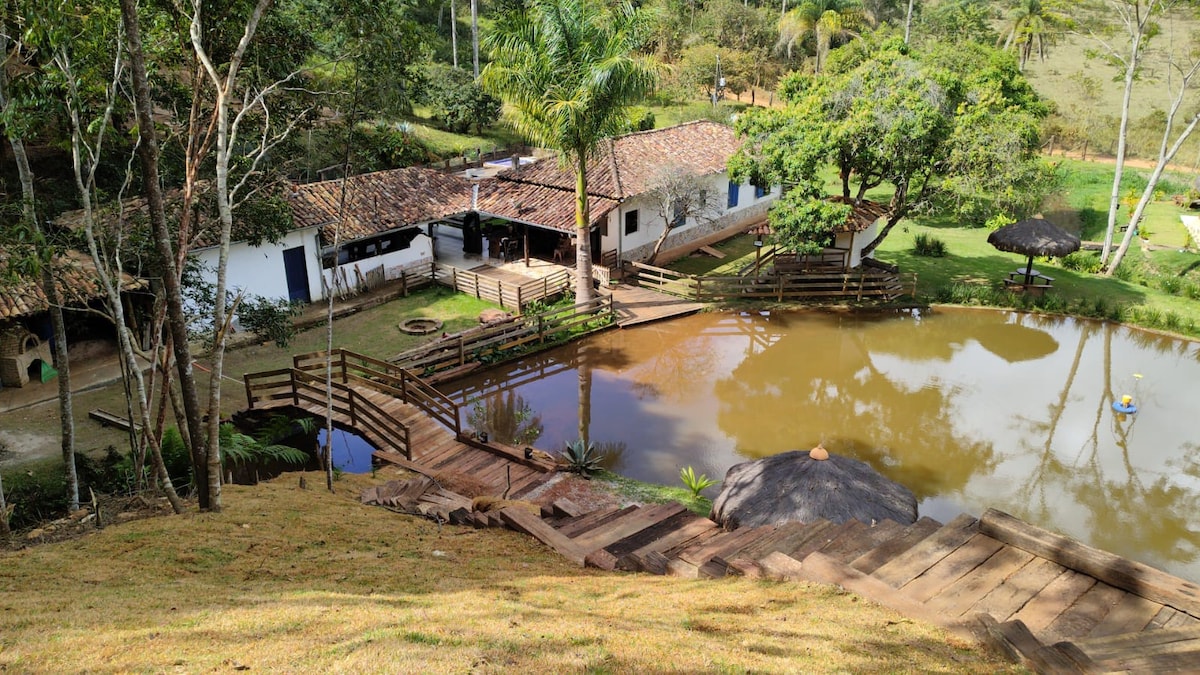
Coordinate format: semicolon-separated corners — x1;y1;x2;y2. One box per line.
244;368;413;460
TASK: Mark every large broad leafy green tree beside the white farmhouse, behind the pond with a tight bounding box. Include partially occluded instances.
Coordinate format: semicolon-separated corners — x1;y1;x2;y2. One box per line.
730;38;1054;252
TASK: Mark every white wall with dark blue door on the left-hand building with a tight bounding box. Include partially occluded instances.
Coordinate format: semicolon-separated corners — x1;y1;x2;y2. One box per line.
191;227;322;300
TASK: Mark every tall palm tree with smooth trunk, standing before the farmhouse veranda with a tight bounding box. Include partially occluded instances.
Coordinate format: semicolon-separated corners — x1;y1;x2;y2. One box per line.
481;0;658;303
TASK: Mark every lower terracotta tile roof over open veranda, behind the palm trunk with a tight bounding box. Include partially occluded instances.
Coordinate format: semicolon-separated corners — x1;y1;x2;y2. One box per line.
475;179;619;234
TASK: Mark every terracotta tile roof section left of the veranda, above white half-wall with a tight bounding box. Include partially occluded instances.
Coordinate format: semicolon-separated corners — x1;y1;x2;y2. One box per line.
288;167;472;244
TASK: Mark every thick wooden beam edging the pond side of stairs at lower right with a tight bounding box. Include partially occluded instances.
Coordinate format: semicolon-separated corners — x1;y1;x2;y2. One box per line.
979;508;1200;619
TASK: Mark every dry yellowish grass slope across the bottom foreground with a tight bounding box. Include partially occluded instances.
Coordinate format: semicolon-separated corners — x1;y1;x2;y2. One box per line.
0;474;1012;673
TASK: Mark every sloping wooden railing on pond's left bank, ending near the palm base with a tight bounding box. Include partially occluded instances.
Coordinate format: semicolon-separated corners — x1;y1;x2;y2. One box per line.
388;295;613;377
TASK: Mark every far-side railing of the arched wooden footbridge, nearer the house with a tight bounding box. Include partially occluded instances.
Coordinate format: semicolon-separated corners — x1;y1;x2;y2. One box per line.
292;350;462;438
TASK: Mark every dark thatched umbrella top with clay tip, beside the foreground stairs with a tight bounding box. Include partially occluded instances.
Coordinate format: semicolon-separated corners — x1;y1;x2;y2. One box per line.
709;446;917;530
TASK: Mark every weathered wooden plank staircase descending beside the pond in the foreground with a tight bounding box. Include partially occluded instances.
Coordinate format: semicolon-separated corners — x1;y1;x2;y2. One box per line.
500;501;1200;673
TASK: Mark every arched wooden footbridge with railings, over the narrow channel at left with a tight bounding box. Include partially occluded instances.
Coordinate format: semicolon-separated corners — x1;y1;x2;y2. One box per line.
244;350;554;498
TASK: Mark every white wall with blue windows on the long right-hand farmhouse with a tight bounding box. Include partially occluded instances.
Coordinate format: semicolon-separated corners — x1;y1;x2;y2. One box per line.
601;172;781;261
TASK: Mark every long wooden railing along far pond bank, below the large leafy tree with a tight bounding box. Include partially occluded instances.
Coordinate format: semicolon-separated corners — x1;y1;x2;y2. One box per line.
630;258;917;303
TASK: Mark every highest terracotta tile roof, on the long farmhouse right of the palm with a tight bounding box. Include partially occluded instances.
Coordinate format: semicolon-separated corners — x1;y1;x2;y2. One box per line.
499;120;742;199
